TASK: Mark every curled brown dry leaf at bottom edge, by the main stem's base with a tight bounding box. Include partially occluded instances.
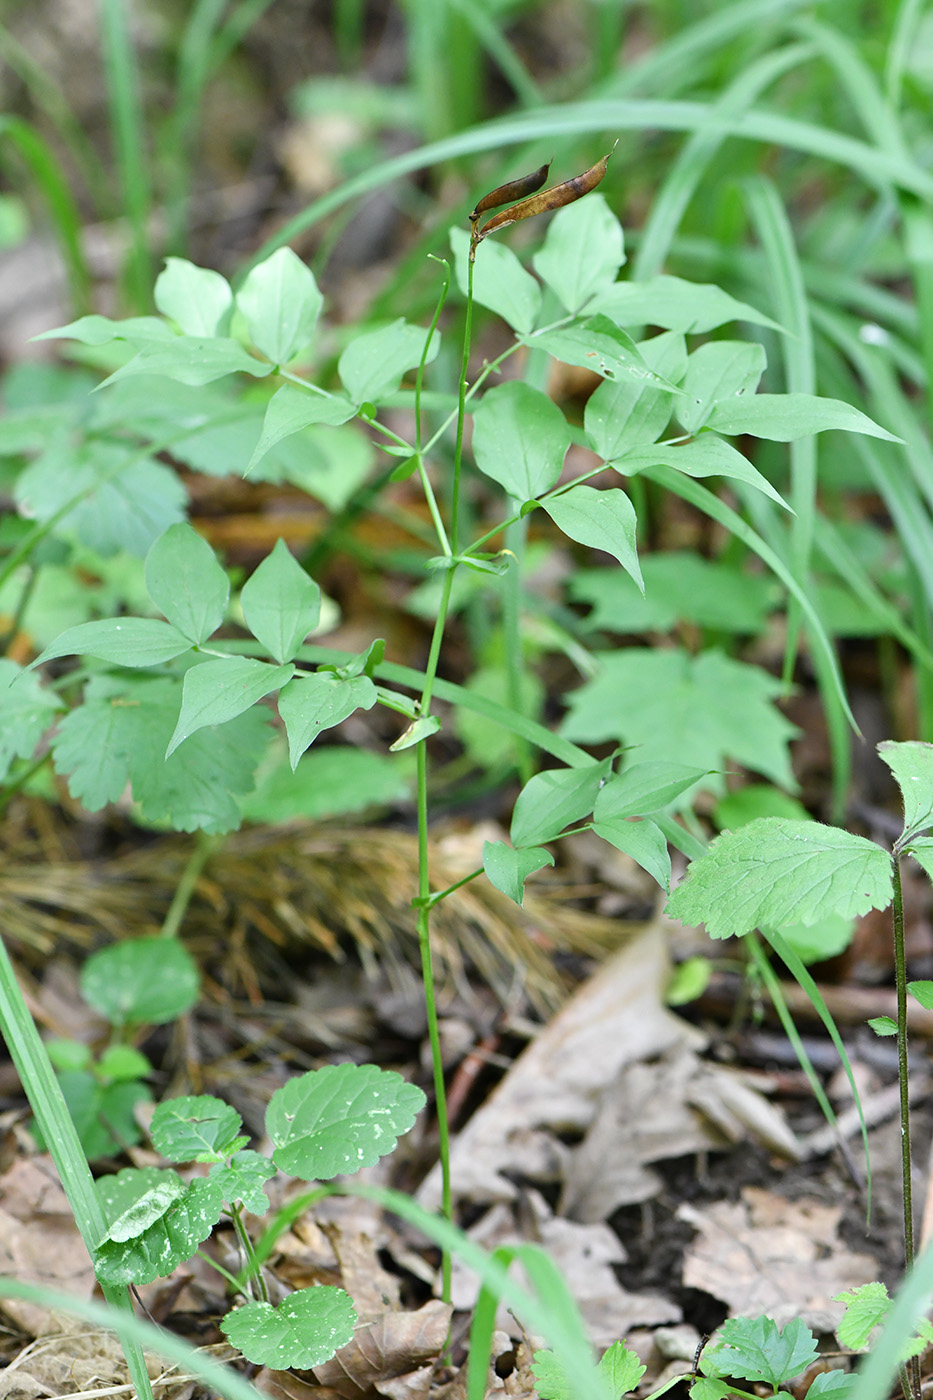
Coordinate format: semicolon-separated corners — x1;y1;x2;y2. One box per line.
314;1299;451;1400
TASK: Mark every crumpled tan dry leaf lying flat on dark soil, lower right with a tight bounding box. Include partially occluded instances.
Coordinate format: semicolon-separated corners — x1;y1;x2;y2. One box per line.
677;1186;878;1331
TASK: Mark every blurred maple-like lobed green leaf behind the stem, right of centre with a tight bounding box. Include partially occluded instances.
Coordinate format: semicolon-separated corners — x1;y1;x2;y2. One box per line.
562;647;797;795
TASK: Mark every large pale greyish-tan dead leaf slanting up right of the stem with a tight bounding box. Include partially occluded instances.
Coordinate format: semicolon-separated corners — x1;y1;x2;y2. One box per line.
417;927;703;1210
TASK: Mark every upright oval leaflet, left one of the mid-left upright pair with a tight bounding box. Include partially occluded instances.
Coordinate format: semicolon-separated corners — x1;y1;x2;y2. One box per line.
146;524;230;644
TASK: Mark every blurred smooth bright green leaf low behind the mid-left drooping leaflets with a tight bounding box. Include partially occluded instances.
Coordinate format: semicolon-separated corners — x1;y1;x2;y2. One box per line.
242;743;410;823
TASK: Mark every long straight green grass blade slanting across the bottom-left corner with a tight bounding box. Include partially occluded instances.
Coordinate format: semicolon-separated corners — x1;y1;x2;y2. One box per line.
0;939;153;1400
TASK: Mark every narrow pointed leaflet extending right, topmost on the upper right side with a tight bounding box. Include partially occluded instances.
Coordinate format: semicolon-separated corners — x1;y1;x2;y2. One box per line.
590;276;782;335
